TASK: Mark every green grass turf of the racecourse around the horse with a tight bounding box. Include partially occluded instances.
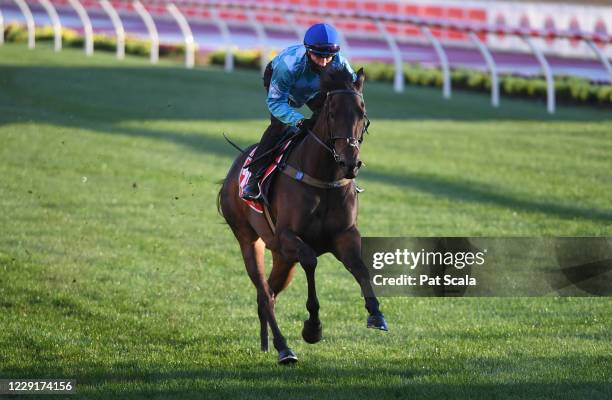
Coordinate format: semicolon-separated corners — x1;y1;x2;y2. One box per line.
0;44;612;399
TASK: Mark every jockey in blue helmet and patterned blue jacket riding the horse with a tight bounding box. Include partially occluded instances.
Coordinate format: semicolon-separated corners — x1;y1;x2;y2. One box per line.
242;24;355;200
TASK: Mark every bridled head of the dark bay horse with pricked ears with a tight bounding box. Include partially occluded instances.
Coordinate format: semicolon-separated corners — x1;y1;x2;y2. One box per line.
319;68;369;179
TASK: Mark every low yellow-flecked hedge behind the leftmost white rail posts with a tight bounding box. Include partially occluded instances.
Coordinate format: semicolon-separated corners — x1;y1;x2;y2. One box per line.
4;24;185;57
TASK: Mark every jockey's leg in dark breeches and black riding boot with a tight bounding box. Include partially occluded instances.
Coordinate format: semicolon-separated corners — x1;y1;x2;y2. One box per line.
242;120;285;200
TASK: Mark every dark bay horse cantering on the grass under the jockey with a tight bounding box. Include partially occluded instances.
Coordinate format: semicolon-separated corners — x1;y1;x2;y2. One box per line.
219;69;387;364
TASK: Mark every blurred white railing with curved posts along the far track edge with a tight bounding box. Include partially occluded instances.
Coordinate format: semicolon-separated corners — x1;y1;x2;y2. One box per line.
0;0;612;114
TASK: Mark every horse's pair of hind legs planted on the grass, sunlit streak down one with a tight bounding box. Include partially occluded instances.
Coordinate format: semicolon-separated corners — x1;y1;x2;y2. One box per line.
240;239;297;363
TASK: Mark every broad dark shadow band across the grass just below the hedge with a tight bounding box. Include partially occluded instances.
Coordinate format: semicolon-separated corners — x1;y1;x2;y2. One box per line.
0;66;612;123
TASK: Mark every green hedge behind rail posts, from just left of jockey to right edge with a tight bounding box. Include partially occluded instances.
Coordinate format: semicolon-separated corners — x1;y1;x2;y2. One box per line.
209;51;612;105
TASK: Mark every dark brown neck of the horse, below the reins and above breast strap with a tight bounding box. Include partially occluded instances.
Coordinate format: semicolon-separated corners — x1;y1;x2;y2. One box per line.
296;114;343;182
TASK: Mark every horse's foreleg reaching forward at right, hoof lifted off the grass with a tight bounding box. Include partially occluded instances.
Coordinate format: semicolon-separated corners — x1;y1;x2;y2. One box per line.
333;227;388;331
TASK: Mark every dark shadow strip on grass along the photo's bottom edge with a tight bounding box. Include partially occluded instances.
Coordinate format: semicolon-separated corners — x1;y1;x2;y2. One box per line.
2;356;612;400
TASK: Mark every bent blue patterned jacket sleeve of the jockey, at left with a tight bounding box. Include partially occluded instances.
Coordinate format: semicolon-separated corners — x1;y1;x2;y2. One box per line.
267;65;304;126
